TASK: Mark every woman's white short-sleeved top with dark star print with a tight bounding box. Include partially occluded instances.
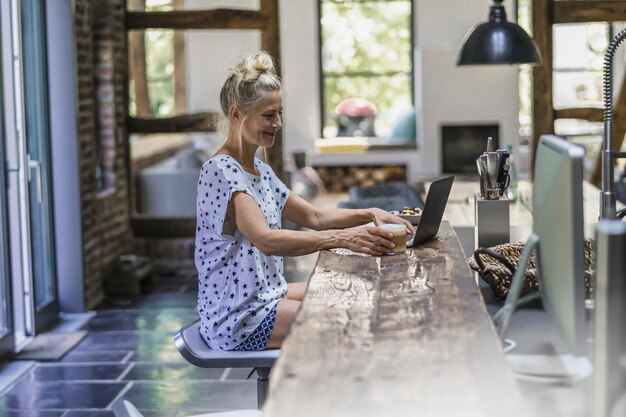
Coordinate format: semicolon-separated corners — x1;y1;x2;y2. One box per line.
195;155;289;350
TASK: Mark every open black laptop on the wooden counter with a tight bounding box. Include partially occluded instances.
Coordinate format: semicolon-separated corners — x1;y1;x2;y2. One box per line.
406;175;454;248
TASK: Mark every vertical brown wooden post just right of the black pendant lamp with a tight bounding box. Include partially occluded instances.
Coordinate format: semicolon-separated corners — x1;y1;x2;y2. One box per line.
530;0;555;176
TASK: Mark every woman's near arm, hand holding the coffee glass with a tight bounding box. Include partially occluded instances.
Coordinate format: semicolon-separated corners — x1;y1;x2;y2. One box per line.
228;192;394;256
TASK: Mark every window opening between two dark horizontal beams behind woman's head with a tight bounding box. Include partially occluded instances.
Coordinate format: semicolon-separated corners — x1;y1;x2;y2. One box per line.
128;29;261;119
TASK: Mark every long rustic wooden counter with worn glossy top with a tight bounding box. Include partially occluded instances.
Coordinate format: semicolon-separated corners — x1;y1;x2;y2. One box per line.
264;222;525;417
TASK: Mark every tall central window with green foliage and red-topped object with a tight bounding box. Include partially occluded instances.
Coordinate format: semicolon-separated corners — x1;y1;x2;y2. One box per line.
320;0;416;143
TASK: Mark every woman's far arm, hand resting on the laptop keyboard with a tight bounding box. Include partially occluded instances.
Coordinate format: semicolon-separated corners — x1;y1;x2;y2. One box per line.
283;193;415;233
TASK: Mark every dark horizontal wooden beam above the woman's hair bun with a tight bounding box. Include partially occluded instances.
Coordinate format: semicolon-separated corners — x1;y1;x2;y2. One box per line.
126;9;267;30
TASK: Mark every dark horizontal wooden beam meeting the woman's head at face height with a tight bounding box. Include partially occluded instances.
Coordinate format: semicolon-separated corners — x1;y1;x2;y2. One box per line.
126;112;220;133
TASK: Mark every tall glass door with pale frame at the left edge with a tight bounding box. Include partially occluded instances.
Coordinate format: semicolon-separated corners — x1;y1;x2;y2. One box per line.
0;0;59;351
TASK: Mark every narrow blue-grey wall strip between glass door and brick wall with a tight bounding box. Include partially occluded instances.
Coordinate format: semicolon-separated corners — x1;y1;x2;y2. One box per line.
46;0;86;313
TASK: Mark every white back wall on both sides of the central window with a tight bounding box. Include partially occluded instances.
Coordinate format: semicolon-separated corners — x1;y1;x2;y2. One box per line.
280;0;518;180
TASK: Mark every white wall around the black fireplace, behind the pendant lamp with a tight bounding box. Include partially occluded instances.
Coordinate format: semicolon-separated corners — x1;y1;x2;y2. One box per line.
416;0;519;174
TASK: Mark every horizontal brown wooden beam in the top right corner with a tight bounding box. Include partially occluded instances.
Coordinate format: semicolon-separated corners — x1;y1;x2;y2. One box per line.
552;0;626;24
